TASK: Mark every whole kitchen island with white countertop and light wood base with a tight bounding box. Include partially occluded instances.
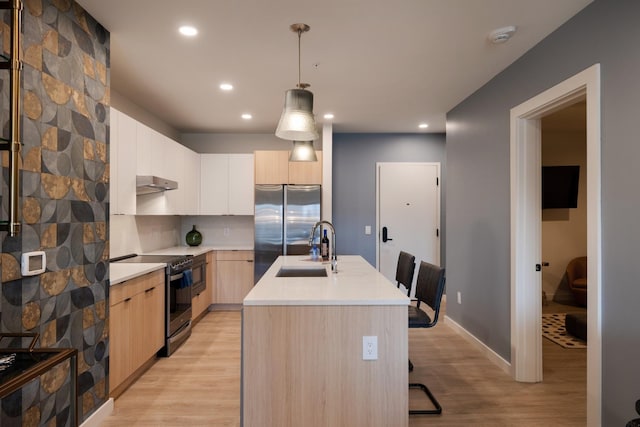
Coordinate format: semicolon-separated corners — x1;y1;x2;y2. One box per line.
241;256;409;427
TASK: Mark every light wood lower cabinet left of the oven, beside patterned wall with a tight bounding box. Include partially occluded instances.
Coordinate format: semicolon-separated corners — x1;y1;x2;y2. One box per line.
109;270;165;393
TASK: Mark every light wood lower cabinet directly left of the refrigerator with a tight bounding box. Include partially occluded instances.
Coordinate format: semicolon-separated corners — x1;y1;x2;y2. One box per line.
215;251;253;304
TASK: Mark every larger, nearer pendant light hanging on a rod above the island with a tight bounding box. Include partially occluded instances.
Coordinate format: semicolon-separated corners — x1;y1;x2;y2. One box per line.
276;24;320;142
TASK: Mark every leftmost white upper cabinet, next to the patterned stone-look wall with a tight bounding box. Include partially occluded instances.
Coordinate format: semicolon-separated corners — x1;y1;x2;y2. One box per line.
109;108;137;215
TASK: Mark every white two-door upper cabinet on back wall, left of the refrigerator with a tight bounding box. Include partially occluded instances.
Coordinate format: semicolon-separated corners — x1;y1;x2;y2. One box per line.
200;154;254;215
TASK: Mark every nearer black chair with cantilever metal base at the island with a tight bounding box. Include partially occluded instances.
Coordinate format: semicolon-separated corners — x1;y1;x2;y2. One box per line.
409;261;445;414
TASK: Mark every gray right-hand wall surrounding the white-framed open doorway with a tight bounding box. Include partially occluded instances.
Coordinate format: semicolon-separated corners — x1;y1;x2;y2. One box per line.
446;0;640;426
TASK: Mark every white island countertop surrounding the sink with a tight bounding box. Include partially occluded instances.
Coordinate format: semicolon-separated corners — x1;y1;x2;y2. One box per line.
244;255;409;306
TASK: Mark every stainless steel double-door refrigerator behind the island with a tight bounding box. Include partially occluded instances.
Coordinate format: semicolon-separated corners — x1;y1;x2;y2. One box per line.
254;184;321;283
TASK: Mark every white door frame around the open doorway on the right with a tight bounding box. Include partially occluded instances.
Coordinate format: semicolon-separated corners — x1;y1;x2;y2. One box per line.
510;64;602;426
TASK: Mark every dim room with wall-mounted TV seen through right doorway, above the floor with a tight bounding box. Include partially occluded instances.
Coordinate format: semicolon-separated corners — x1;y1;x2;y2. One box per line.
540;103;587;314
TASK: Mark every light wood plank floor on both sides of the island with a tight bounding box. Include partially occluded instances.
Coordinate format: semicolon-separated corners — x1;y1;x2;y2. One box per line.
102;306;586;427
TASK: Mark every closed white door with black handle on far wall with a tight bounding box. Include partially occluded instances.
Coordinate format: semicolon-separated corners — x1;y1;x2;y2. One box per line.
376;163;440;295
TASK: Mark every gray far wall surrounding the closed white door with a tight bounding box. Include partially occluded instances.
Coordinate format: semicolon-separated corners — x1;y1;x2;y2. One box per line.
333;134;446;266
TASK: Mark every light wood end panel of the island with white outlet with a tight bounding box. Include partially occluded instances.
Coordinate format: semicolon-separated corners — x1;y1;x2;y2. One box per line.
241;306;408;427
